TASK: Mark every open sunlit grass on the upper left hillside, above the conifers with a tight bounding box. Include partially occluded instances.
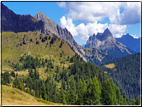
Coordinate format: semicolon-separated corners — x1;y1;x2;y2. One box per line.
2;32;75;75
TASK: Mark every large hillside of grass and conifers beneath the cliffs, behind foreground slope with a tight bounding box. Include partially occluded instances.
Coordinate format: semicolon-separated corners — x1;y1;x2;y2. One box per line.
2;32;135;105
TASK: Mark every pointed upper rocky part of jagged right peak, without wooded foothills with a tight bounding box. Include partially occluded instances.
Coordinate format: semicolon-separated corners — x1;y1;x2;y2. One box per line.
85;28;133;58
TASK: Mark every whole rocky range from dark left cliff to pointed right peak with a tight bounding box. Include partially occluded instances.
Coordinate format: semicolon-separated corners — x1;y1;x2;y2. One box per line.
1;4;140;65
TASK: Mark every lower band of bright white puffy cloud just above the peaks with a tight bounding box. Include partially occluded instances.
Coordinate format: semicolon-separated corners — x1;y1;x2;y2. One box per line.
60;16;127;40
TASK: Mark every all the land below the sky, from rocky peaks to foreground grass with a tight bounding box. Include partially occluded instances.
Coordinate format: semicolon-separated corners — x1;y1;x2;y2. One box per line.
1;3;141;105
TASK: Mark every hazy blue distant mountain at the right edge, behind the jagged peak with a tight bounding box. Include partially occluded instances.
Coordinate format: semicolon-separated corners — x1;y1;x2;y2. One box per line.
115;33;141;53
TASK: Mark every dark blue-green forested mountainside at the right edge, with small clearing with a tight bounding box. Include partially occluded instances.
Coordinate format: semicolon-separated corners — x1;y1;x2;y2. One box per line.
101;53;141;99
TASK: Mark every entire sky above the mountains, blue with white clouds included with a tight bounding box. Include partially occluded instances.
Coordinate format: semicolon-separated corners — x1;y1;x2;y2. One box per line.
3;2;141;45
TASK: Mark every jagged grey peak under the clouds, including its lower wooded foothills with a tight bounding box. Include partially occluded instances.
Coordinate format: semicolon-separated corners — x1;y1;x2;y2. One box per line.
84;28;135;65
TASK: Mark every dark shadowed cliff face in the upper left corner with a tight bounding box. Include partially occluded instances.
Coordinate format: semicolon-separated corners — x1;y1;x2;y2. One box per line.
1;4;44;32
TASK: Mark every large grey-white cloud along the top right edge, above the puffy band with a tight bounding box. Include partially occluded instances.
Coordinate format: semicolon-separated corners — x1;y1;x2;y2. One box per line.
57;2;141;24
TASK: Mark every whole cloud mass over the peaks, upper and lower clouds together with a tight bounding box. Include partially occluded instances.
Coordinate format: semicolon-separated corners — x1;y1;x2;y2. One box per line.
57;2;141;40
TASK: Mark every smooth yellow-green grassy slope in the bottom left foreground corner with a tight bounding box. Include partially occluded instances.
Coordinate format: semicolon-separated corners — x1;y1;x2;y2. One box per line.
2;85;61;105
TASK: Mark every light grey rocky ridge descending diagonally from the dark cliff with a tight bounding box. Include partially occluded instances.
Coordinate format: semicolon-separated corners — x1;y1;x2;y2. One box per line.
34;12;86;61
